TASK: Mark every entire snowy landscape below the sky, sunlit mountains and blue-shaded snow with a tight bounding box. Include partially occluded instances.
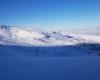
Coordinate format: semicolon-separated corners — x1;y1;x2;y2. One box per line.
0;26;100;80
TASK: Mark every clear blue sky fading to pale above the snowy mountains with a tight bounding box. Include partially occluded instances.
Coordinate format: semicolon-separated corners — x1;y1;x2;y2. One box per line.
0;0;100;30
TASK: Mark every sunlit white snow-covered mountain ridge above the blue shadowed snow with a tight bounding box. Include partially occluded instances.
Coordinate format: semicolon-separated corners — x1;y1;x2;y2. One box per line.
0;25;100;46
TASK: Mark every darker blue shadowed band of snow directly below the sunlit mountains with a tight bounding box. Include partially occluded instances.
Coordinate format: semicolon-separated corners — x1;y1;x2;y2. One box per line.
0;44;100;57
